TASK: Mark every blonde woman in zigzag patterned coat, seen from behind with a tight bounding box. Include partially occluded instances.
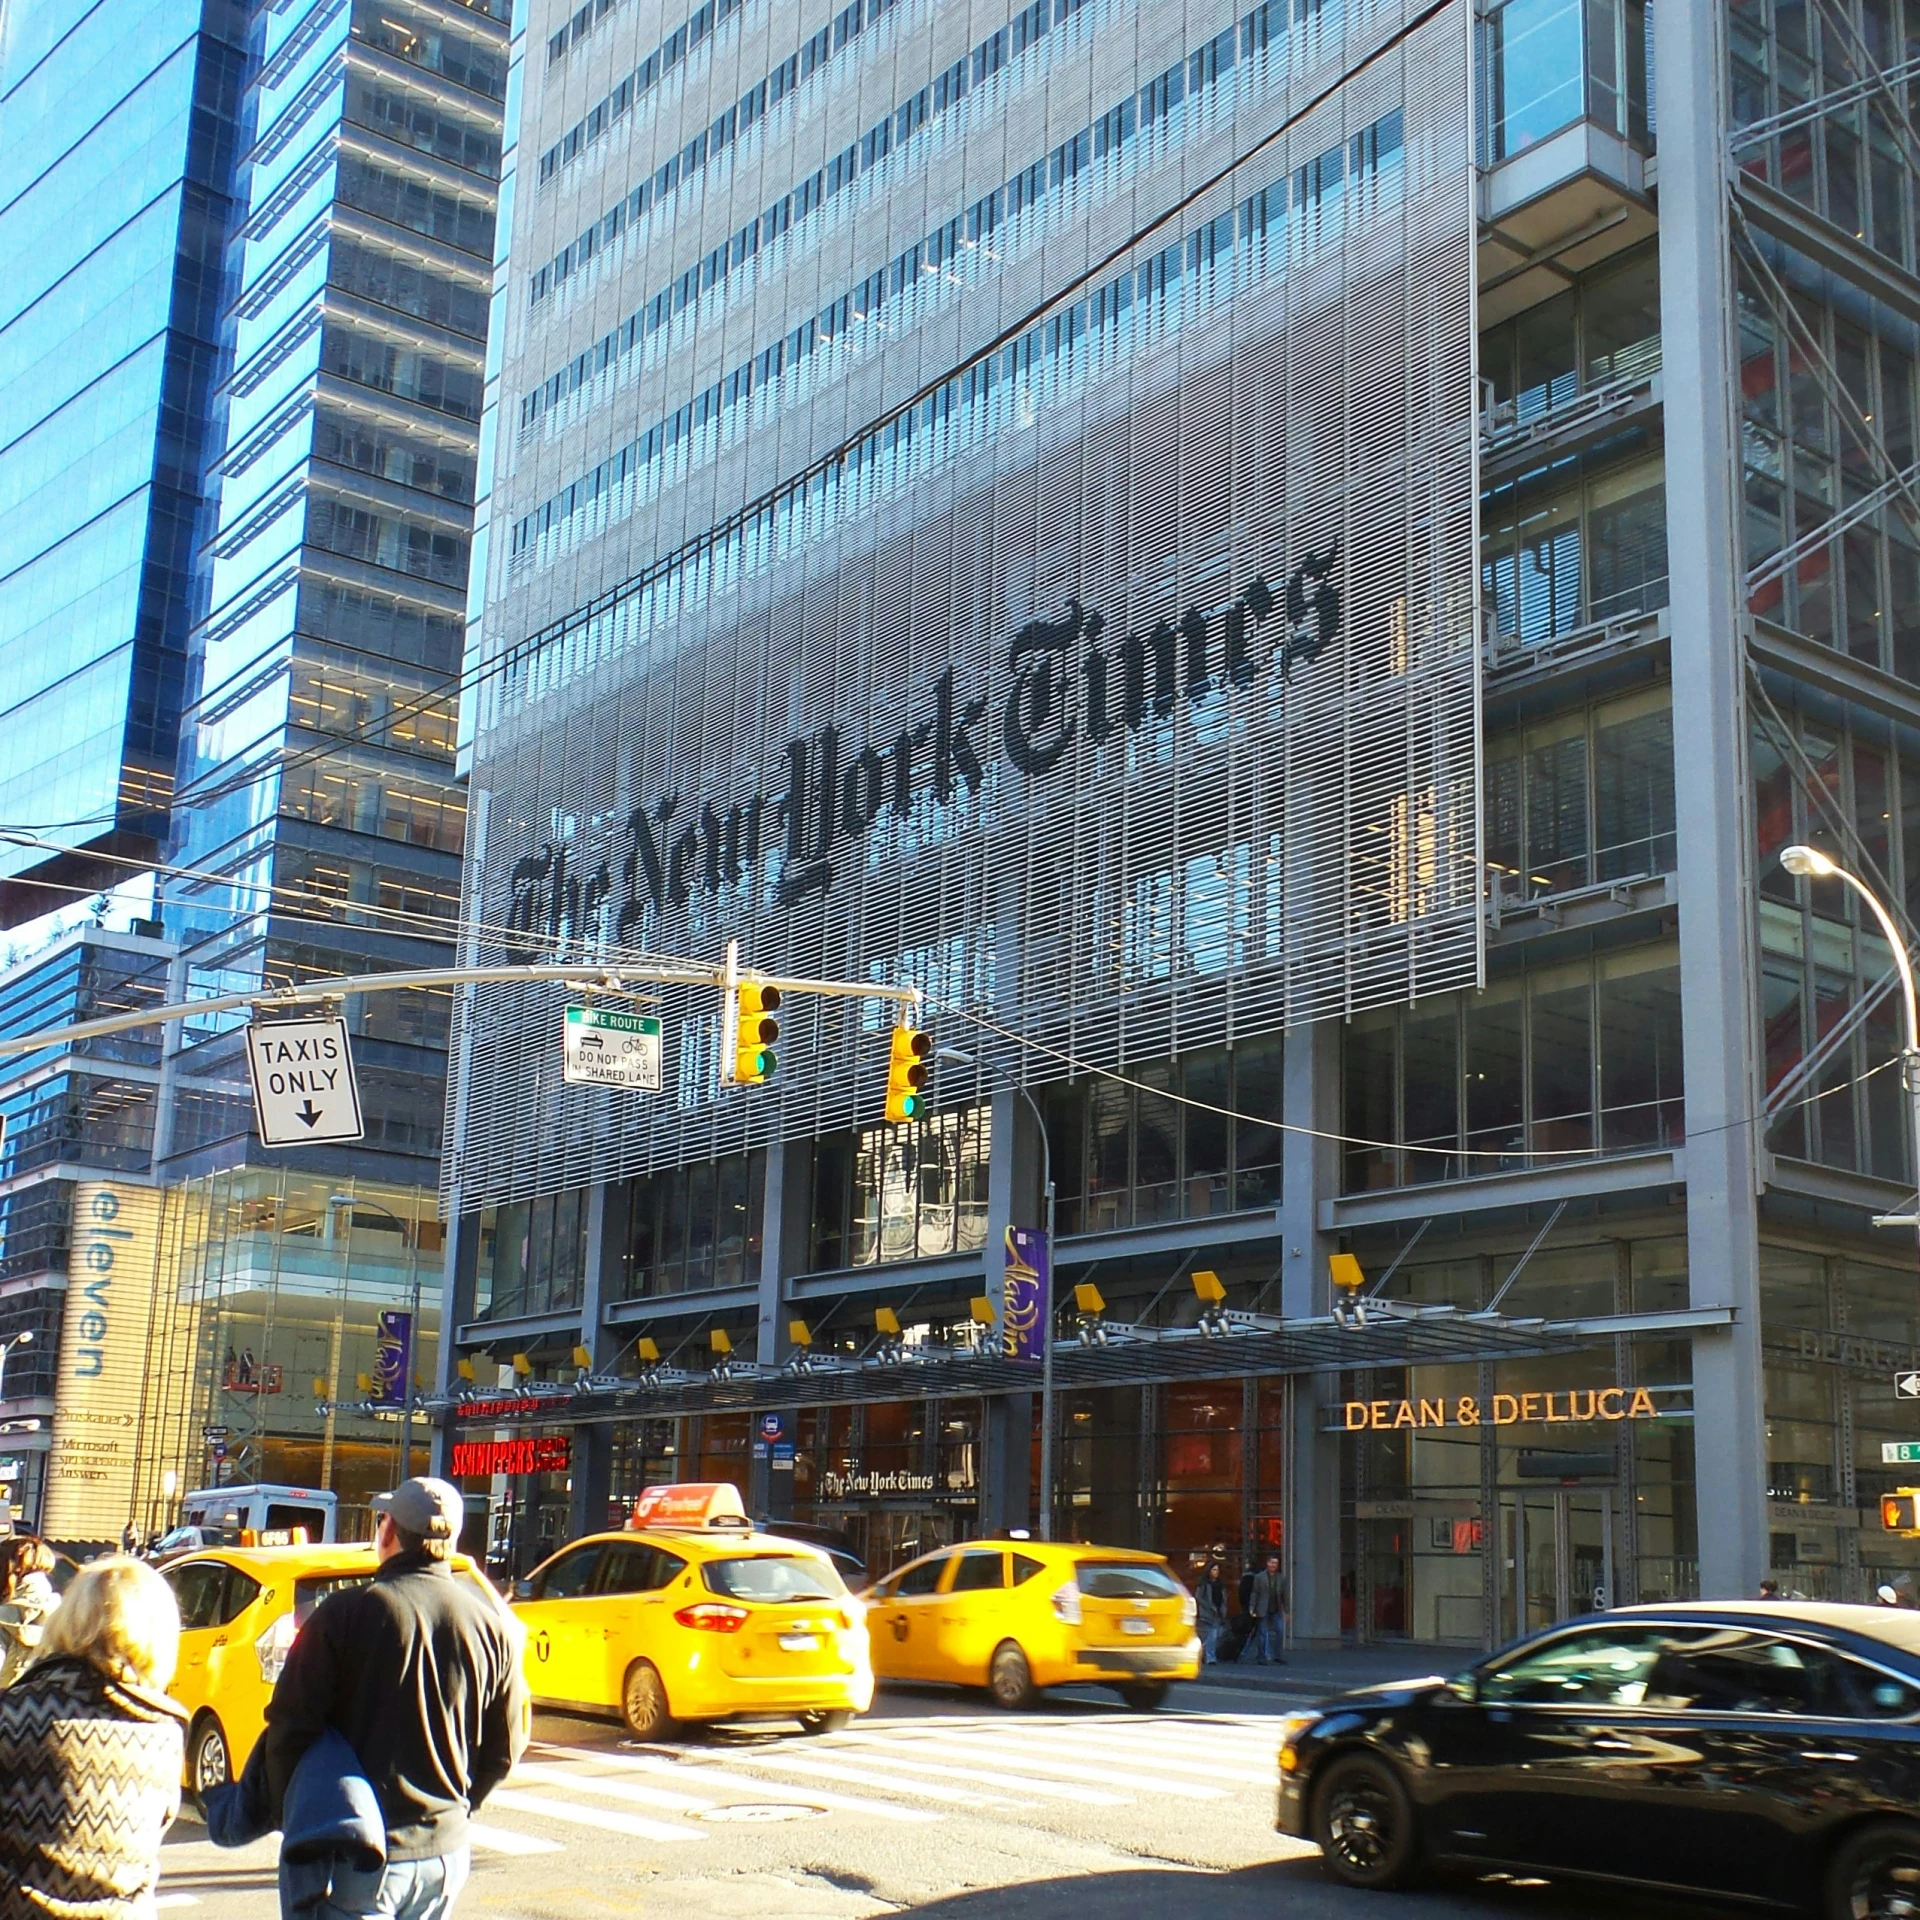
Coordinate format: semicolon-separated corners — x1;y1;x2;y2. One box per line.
0;1553;186;1920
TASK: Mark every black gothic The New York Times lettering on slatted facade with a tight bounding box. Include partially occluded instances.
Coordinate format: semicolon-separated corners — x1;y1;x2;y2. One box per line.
507;547;1342;952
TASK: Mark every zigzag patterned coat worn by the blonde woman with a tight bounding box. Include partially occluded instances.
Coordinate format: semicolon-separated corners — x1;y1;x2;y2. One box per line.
0;1659;186;1920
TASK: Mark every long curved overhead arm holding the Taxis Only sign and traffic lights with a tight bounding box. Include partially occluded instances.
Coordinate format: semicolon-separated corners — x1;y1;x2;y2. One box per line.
0;956;920;1056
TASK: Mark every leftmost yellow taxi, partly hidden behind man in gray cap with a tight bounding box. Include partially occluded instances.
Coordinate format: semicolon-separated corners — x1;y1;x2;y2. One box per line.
159;1542;505;1793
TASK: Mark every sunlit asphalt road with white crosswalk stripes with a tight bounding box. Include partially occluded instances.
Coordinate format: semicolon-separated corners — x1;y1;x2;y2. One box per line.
149;1686;1743;1920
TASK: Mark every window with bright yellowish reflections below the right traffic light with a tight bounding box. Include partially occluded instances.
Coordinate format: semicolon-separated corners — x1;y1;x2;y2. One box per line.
810;1106;993;1273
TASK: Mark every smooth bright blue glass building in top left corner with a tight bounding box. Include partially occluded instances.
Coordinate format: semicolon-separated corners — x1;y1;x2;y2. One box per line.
0;0;244;925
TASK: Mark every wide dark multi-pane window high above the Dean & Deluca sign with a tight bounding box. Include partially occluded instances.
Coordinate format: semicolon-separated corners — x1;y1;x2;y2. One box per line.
1342;943;1686;1192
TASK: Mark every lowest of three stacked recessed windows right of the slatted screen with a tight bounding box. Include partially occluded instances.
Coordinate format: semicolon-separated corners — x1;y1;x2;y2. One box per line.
1486;687;1674;902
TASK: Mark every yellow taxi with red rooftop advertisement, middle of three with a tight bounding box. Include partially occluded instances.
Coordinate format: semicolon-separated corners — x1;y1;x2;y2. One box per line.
513;1482;874;1740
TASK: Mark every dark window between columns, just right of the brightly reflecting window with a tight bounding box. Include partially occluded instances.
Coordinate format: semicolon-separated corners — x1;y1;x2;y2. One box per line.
1043;1035;1284;1233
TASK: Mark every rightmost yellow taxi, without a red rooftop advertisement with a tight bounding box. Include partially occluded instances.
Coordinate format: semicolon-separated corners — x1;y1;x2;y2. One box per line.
866;1540;1200;1711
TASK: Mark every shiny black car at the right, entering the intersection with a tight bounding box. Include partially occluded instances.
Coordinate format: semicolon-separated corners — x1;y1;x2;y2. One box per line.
1275;1601;1920;1920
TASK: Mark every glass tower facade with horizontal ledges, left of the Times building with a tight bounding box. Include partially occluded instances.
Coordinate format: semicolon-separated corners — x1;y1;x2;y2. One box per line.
163;0;507;1185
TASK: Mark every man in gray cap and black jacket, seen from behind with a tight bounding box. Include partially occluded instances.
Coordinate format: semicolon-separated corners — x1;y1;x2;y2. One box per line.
263;1478;528;1920
